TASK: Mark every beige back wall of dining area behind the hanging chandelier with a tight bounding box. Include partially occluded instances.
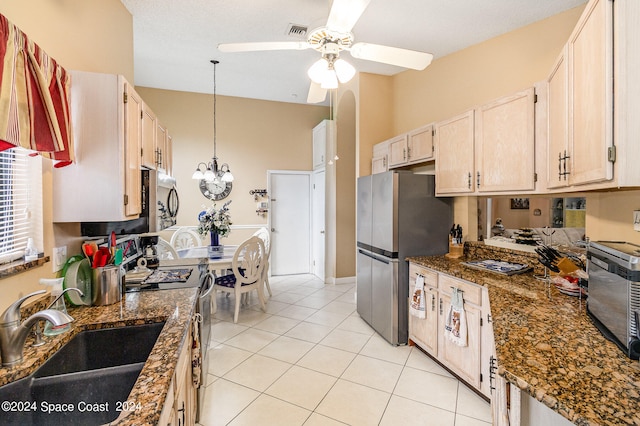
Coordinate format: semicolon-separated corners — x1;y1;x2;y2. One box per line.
136;86;329;244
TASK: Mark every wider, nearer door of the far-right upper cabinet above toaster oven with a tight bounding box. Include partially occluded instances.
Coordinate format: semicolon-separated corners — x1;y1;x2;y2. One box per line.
568;0;613;185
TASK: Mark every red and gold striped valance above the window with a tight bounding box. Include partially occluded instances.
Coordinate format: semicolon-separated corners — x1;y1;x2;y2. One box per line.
0;14;73;167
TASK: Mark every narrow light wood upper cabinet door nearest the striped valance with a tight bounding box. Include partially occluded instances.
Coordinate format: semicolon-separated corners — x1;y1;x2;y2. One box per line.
123;83;142;216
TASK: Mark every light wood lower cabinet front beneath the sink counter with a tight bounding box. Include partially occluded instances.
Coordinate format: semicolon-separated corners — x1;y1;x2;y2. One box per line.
158;322;198;426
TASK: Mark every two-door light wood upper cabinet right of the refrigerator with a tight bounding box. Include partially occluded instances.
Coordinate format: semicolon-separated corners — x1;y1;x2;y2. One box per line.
435;88;537;195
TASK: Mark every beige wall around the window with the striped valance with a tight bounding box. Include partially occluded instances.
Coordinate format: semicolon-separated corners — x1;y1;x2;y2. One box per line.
0;0;133;312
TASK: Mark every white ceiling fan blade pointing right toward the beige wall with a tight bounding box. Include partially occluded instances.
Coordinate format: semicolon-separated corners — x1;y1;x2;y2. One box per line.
349;43;433;70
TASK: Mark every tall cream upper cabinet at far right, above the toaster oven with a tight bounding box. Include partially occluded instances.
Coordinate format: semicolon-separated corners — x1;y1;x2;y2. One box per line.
547;0;640;192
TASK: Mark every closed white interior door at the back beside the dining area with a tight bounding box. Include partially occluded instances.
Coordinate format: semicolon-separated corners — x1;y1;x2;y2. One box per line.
268;171;311;275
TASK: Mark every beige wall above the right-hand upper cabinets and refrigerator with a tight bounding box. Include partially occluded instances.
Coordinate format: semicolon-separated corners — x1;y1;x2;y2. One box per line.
393;6;584;134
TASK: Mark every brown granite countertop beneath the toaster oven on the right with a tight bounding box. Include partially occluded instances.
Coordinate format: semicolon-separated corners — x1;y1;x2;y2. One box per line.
407;250;640;425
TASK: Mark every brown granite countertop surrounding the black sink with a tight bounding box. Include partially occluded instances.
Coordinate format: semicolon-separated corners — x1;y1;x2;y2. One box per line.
0;288;198;425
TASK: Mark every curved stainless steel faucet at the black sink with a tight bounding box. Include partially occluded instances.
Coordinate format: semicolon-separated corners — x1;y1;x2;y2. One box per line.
0;290;73;367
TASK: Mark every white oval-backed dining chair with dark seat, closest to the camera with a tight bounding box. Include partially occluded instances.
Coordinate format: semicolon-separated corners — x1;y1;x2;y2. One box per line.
212;236;267;323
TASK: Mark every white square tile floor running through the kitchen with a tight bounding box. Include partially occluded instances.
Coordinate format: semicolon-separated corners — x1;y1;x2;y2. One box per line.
200;275;491;426
